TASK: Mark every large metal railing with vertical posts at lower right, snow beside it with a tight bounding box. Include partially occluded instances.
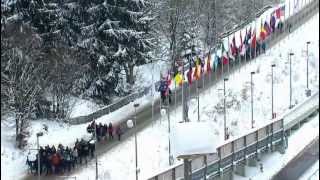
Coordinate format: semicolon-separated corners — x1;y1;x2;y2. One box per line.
149;87;319;180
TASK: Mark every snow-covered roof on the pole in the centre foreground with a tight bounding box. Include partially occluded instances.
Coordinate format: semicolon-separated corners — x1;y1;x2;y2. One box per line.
170;122;218;158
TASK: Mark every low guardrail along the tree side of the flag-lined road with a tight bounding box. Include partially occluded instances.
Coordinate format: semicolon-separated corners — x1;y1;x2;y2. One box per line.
67;2;280;124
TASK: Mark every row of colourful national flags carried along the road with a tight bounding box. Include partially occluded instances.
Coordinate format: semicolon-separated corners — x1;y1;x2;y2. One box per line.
159;5;285;91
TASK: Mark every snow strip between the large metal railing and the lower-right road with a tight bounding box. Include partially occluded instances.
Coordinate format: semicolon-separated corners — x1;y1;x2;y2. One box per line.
234;113;319;180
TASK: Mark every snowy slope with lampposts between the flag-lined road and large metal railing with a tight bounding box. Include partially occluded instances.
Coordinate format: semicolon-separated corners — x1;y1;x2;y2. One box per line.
65;11;319;180
